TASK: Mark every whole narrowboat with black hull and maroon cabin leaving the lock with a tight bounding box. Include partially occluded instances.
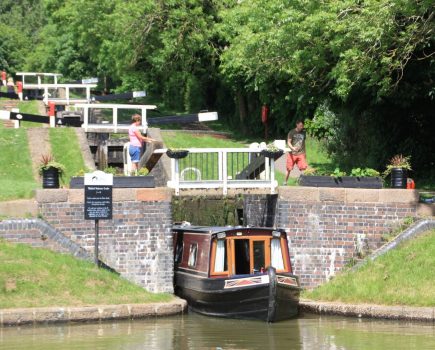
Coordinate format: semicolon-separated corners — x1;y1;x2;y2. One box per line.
173;225;300;322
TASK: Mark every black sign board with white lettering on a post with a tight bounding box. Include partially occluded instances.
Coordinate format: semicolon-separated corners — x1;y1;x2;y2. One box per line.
85;185;112;220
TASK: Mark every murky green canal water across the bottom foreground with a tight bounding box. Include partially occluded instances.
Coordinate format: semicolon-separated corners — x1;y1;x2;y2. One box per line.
0;313;435;350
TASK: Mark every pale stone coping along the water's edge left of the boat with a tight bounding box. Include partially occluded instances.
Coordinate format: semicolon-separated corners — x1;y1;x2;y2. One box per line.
0;298;187;327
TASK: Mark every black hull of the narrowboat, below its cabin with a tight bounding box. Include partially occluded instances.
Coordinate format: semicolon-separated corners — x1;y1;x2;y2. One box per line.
175;268;300;322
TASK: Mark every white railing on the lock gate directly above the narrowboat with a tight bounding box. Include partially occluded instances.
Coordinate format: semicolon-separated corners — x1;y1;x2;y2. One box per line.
159;148;278;195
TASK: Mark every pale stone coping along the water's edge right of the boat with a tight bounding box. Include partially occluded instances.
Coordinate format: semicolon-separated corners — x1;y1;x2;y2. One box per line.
299;300;435;322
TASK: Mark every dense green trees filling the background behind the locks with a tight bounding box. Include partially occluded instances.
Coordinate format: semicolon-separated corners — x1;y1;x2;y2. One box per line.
0;0;435;183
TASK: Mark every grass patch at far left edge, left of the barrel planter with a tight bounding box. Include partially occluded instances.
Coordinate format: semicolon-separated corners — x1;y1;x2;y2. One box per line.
0;128;39;201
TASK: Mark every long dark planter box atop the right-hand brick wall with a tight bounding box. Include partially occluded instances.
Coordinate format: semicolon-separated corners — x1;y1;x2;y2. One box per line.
299;175;383;188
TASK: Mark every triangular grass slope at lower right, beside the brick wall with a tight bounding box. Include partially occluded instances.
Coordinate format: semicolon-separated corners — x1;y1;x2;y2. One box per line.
303;230;435;307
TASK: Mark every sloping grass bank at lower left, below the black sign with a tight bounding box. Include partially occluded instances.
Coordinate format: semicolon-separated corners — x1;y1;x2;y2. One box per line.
0;240;172;308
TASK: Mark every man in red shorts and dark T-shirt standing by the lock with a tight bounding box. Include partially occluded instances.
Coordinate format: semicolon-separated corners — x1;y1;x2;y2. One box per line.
284;120;308;185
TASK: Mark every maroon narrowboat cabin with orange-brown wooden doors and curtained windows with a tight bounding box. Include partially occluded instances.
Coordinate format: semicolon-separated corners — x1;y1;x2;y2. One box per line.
173;225;292;278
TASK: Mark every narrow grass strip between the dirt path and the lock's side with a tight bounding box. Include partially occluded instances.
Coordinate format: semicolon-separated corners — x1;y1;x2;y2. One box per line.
50;128;85;184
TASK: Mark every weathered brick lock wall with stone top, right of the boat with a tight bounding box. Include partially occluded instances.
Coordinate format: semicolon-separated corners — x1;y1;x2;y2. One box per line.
245;187;418;288
